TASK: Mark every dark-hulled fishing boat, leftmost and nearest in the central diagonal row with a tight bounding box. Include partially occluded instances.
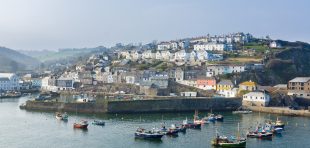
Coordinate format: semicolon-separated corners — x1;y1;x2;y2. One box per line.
135;128;164;139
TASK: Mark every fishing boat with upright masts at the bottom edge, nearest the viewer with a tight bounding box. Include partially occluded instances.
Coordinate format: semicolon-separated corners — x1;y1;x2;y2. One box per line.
211;124;246;148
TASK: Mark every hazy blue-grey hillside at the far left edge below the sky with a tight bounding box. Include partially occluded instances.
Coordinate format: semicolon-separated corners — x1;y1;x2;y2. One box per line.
0;47;40;72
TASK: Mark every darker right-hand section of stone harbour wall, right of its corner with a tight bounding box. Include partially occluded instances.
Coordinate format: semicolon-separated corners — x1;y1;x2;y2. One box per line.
108;98;241;113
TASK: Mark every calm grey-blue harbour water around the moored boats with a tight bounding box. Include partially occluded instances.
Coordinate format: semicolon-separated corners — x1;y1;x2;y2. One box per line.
0;97;310;148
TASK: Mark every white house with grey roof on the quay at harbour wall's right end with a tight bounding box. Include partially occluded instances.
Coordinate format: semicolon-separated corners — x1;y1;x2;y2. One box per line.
242;92;270;106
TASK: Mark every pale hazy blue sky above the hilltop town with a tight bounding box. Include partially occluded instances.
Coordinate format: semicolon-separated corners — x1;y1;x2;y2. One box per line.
0;0;310;50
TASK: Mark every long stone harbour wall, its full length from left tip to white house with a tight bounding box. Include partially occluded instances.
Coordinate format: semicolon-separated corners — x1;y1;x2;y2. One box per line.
21;98;241;113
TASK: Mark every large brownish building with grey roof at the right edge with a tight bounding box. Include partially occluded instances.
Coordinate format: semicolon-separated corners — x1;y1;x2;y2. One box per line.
287;77;310;98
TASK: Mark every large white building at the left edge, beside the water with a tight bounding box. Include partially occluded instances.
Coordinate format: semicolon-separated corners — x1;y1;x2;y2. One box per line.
0;73;20;91
